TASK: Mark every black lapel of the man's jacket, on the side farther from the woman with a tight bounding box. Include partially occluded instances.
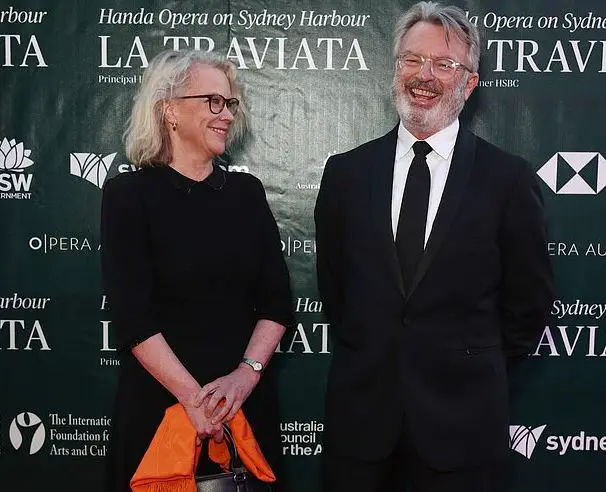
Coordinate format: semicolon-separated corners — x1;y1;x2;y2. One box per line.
406;128;476;299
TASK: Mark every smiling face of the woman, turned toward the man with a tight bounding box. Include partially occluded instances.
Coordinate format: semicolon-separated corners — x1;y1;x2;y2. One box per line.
167;65;234;159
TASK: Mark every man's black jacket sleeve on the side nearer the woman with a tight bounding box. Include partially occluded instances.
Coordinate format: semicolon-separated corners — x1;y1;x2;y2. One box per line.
314;157;343;325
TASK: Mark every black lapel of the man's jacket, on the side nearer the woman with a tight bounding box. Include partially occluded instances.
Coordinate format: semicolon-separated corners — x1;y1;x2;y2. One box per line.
370;125;405;297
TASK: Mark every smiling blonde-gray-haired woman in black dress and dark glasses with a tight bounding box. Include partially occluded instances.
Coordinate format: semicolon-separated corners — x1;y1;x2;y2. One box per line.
101;51;292;492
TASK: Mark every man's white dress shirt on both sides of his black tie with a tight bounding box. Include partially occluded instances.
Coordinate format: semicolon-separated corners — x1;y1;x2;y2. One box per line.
391;119;459;246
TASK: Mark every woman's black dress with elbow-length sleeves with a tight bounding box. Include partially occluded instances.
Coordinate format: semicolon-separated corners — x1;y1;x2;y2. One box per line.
101;166;292;492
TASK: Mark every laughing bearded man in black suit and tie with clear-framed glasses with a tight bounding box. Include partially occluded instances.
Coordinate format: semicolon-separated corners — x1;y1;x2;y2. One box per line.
315;2;552;492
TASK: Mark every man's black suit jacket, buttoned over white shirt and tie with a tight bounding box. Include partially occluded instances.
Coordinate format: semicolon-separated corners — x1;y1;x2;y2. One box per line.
315;123;553;470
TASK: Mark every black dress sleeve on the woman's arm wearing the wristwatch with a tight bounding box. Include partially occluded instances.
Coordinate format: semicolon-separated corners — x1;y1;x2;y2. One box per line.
254;180;294;328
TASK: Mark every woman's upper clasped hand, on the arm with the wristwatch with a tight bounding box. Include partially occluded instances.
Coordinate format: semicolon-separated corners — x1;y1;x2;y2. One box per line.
194;366;261;425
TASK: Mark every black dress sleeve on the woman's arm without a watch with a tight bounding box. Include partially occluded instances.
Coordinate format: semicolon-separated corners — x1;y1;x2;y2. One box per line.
101;175;161;350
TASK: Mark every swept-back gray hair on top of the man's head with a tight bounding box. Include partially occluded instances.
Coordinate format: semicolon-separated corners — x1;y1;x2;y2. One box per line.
393;2;480;72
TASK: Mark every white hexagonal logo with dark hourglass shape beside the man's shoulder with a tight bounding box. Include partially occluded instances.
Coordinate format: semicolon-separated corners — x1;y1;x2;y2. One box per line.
537;152;606;195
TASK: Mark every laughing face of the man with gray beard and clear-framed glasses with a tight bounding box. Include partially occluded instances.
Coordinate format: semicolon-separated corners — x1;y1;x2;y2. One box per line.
393;22;478;139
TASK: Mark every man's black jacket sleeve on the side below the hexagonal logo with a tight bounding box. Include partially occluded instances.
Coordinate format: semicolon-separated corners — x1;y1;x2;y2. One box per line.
499;163;554;357
